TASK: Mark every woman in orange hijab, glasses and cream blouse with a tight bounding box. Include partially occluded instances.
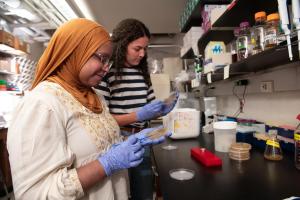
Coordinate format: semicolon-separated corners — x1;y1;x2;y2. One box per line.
7;19;170;200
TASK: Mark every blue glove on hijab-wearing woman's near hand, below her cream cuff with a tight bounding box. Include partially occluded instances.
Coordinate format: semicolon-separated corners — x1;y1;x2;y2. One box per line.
98;135;145;176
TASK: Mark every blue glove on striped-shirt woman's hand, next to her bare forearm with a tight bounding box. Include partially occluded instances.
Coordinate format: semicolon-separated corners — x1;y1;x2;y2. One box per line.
136;100;164;122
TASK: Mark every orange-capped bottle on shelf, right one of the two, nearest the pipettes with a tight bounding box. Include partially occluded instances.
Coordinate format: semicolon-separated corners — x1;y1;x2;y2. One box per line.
265;13;280;49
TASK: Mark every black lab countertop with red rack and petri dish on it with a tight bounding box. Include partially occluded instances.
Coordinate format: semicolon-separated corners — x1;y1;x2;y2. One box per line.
153;134;300;200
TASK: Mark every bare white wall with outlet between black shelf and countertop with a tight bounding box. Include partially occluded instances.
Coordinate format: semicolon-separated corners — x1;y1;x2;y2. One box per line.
207;62;300;126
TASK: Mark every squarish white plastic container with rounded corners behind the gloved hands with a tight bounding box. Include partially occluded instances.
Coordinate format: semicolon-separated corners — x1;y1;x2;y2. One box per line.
163;108;200;139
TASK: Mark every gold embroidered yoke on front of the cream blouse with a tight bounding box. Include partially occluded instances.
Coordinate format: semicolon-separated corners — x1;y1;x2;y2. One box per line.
39;81;122;154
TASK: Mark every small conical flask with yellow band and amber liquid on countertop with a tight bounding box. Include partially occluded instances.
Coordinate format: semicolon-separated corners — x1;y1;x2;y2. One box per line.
264;129;283;161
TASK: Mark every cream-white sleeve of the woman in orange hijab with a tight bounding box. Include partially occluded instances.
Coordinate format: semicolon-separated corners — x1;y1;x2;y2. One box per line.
7;96;84;200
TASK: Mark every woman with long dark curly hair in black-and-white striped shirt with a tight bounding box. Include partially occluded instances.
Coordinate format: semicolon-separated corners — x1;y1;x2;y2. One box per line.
96;19;176;199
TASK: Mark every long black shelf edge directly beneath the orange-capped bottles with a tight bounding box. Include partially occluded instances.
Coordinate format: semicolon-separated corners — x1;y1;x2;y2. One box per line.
202;42;299;83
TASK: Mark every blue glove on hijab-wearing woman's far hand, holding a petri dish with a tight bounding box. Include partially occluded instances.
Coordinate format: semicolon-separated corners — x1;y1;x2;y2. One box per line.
135;126;172;146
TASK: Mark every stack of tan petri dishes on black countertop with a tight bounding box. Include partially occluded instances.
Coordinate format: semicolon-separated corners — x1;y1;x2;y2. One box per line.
229;142;251;161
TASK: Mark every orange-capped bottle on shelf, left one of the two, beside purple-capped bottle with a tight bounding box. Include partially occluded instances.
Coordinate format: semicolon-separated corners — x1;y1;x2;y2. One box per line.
251;11;267;55
